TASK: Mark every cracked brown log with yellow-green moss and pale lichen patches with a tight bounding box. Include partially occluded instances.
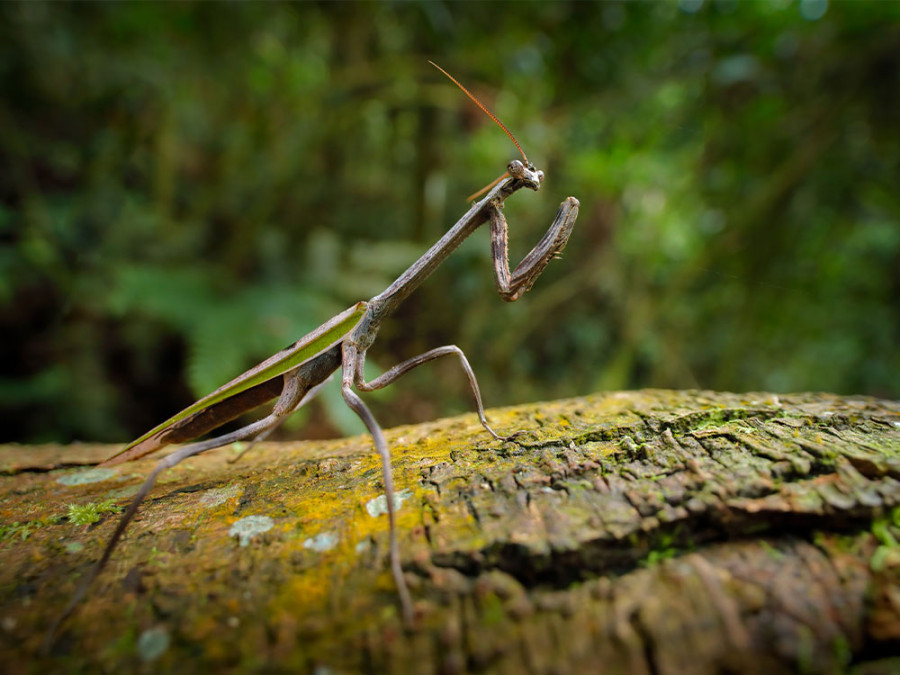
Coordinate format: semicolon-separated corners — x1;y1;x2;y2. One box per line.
0;390;900;674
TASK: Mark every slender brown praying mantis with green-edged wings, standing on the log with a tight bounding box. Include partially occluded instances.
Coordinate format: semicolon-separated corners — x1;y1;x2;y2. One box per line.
48;62;579;642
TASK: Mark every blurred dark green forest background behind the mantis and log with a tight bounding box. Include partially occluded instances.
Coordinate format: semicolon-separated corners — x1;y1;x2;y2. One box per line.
0;0;900;442
